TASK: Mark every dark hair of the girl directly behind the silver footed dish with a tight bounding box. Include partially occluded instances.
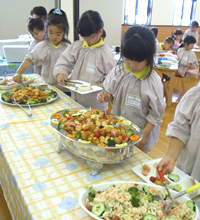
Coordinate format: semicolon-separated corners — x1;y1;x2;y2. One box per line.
121;25;155;69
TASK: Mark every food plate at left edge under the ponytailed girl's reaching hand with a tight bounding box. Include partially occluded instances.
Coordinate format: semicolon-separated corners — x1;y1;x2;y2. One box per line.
0;74;37;90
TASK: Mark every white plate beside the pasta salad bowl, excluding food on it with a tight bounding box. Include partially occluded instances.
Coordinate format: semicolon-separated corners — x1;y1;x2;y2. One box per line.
132;158;200;198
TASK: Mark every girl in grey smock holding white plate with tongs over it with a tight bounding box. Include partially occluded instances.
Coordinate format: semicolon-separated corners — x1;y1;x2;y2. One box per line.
54;10;116;110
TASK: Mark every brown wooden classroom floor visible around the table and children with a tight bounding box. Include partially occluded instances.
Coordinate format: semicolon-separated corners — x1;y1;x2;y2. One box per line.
0;71;200;220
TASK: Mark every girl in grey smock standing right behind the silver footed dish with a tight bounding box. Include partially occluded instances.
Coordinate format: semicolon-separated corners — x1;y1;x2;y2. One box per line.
98;26;166;153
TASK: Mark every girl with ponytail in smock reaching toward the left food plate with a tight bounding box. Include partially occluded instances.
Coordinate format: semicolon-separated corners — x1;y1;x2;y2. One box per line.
13;9;70;90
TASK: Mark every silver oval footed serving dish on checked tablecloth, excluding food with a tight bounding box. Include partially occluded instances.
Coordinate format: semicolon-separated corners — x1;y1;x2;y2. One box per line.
49;108;142;175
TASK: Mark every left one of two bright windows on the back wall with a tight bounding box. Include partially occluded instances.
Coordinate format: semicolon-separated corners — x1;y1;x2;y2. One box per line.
124;0;152;25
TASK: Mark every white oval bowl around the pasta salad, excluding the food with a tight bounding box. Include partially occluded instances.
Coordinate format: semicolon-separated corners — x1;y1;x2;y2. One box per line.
79;181;199;220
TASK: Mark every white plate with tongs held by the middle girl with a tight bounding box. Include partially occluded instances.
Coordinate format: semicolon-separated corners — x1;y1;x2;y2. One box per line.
61;80;102;95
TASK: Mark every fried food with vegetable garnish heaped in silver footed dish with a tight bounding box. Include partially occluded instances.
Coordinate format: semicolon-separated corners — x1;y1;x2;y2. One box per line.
50;109;142;147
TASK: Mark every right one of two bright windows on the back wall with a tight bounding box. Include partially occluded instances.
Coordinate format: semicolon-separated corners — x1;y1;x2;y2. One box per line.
173;0;197;26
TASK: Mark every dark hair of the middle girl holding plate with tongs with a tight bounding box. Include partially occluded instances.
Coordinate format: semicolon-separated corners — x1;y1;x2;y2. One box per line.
76;10;104;37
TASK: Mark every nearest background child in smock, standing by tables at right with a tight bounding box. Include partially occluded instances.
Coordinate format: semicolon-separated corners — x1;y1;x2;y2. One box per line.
176;35;199;77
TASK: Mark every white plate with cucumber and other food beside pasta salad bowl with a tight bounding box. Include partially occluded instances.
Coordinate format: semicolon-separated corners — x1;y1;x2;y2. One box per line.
132;158;200;198
